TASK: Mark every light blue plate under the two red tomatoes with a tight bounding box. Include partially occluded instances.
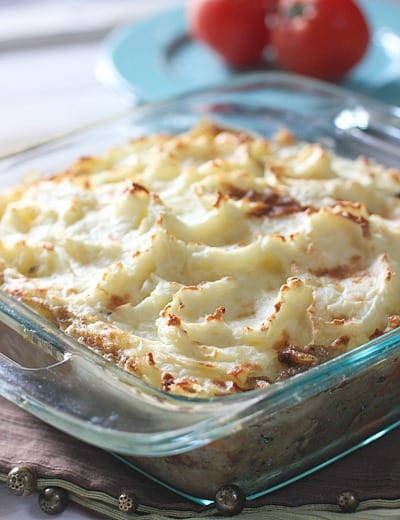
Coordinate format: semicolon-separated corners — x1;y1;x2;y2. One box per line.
96;0;400;105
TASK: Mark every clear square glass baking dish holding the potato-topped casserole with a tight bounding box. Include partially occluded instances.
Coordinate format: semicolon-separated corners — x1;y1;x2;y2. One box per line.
0;72;400;504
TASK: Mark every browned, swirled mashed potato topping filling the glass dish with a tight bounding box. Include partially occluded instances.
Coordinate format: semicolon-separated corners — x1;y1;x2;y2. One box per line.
0;122;400;397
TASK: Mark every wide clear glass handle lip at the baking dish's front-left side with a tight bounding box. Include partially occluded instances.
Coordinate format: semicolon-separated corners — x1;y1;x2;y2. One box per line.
0;325;258;456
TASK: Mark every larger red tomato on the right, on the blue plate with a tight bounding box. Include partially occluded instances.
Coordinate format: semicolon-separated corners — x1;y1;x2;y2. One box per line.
271;0;370;81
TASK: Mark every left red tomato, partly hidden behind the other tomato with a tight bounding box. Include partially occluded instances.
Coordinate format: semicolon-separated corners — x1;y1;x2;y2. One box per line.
187;0;277;67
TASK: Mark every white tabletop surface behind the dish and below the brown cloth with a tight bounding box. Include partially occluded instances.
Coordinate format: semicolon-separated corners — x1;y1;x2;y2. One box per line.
0;4;400;520
